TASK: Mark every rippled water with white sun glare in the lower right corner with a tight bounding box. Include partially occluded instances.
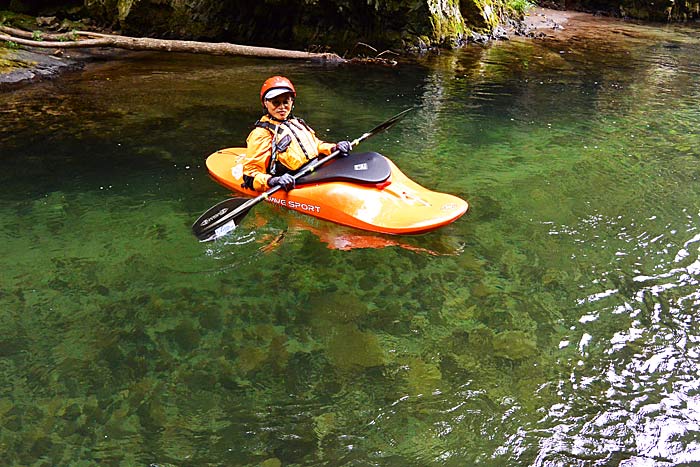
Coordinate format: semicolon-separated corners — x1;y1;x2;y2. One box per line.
500;210;700;466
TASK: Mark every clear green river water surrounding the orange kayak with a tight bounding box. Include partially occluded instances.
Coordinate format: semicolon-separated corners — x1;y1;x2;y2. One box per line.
0;13;700;467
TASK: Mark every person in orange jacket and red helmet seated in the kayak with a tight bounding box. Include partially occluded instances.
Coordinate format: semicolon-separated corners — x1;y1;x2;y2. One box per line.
243;76;351;191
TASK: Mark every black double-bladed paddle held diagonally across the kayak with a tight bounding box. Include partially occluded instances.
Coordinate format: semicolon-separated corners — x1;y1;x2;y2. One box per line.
192;108;413;242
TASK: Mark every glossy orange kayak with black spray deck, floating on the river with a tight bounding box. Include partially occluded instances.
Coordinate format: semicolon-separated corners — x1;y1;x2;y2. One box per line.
207;148;469;234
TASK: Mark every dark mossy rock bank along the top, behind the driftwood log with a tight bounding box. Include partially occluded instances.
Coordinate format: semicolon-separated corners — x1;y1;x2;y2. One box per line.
0;0;700;56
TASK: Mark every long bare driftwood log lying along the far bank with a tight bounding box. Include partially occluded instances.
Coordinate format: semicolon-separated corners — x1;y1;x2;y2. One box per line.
0;25;346;63
